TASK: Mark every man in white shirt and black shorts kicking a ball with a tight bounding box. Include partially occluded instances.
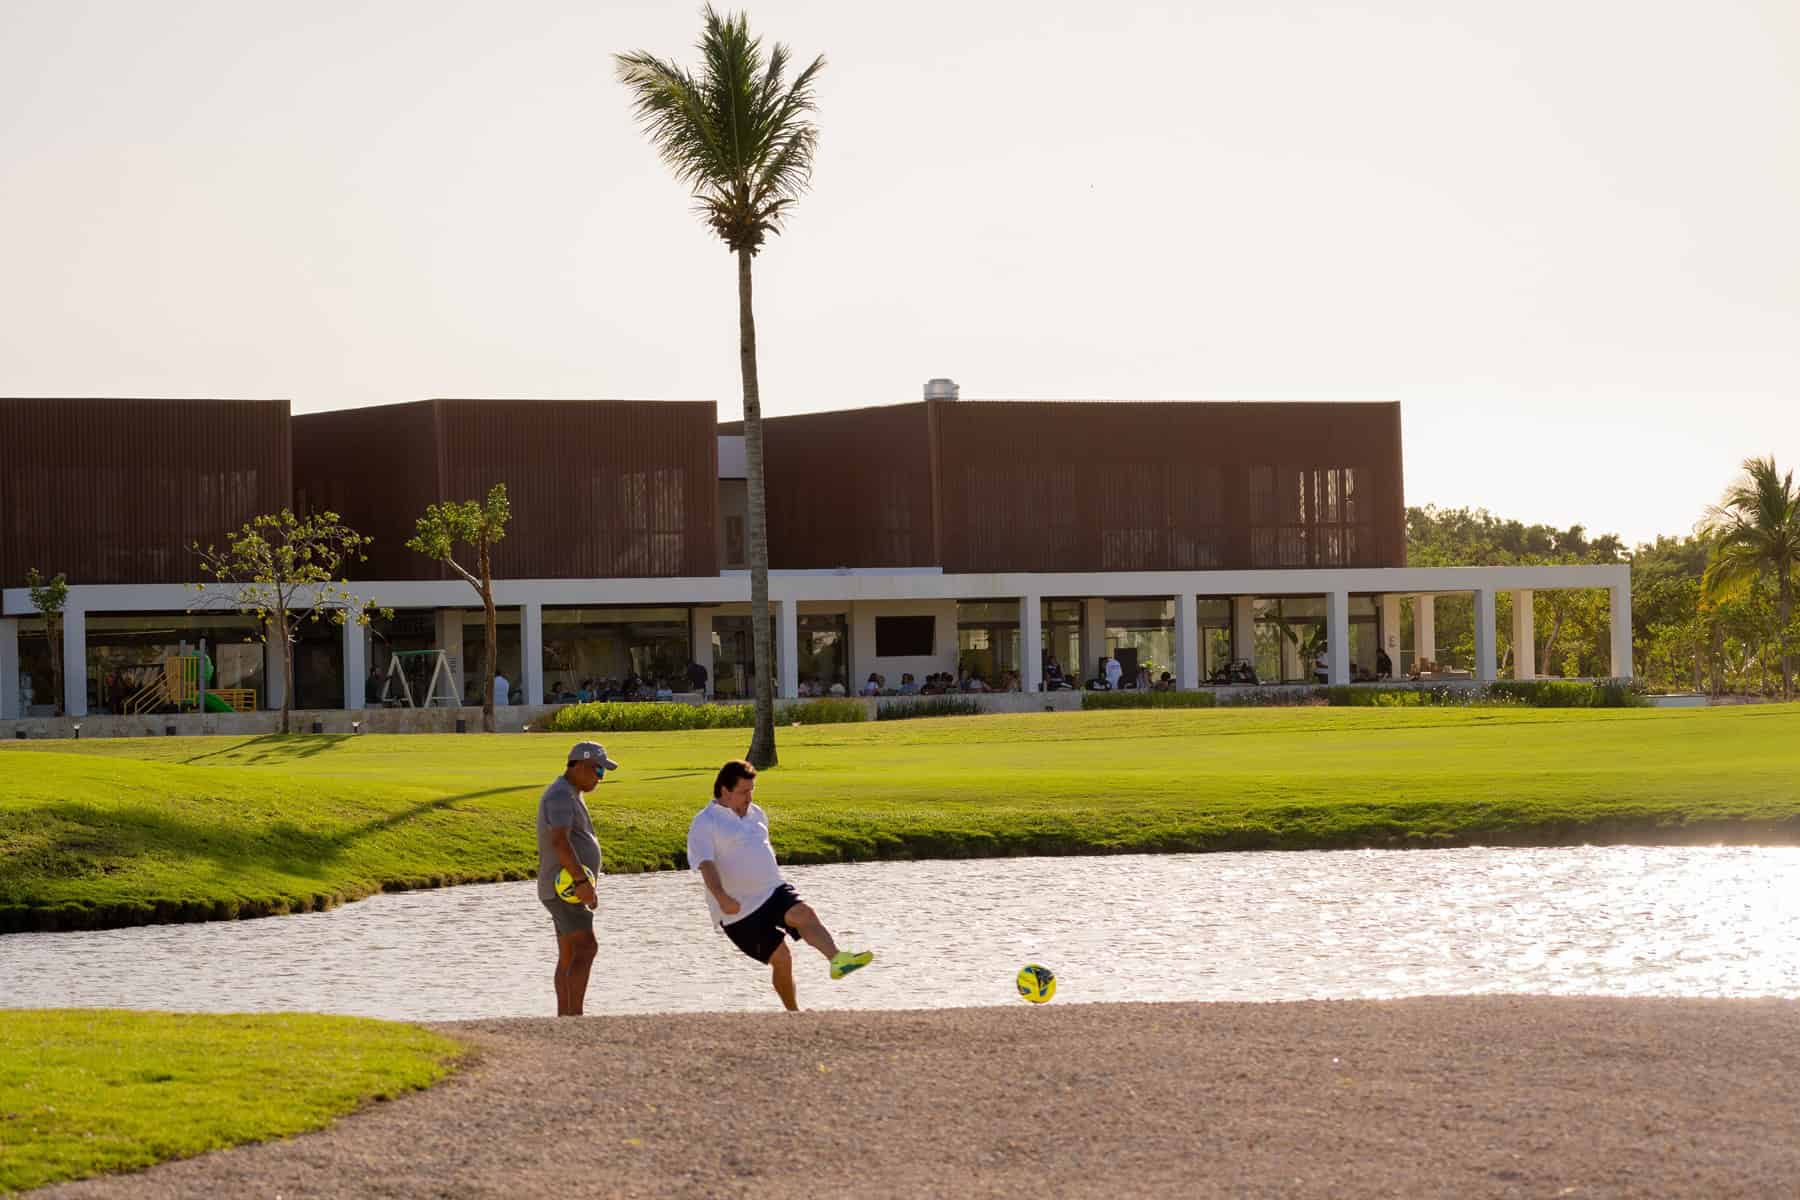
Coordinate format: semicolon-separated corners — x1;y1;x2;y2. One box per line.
688;761;875;1013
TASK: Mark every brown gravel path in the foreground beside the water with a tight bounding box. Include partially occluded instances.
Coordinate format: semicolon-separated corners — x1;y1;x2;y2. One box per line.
40;997;1800;1200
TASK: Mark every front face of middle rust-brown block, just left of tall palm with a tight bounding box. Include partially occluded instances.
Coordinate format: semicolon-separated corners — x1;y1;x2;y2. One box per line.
436;399;718;579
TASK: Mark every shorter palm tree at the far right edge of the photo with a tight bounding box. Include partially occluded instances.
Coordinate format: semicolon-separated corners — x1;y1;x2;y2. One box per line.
1701;455;1800;698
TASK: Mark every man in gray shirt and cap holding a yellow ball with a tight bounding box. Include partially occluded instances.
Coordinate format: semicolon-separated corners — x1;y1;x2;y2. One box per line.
538;741;619;1016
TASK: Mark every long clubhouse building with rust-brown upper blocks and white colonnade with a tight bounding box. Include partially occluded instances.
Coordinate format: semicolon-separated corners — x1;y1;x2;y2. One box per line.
0;390;1631;723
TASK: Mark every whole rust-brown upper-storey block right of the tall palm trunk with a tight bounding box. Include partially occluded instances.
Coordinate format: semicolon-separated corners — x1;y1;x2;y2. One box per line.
763;399;1406;574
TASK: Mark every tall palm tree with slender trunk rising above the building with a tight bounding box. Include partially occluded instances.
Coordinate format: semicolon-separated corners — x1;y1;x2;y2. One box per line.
614;4;824;768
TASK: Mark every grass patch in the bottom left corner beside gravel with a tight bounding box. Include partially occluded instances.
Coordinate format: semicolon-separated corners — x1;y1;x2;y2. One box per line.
0;1009;461;1193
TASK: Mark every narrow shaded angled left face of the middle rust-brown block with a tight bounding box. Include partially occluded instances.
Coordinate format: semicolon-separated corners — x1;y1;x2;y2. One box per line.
293;399;446;579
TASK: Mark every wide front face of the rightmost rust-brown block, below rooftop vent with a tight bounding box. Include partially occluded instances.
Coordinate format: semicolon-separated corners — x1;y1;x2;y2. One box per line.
932;401;1406;572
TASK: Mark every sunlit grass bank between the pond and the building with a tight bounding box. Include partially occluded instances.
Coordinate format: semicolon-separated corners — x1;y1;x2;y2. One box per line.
0;705;1800;930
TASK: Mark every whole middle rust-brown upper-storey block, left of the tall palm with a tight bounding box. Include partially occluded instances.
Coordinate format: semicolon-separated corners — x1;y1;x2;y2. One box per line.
293;399;718;579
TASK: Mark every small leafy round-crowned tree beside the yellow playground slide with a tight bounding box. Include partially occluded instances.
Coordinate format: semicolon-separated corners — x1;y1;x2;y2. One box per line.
193;509;392;732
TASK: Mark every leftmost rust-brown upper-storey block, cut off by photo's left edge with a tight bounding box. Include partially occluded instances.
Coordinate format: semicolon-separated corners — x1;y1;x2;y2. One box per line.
0;398;290;587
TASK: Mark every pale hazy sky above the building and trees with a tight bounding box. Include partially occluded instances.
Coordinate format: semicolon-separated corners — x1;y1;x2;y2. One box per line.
0;0;1800;542
